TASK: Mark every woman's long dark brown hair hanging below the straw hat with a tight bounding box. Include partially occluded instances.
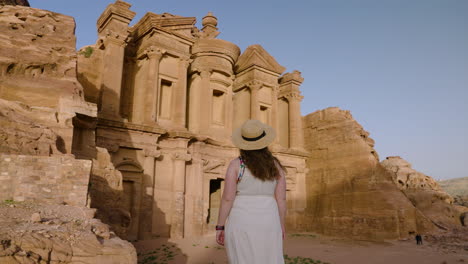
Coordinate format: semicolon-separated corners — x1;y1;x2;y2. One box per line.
240;148;284;181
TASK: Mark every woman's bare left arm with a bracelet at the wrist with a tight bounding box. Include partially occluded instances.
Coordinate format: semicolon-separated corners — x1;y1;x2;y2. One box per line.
217;159;240;226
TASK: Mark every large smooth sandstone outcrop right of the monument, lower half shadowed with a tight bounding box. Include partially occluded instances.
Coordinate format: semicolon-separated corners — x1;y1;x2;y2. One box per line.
303;107;434;240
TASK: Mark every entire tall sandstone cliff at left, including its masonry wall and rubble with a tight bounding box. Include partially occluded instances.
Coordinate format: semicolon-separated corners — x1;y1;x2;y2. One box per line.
0;5;136;263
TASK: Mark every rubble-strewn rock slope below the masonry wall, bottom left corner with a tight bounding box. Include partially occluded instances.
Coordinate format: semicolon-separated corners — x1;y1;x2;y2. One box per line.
0;201;137;264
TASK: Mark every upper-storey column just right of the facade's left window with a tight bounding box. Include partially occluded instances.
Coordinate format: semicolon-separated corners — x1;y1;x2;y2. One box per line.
173;58;190;128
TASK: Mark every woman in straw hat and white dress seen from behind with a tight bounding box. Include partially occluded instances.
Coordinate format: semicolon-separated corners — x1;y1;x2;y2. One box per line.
216;120;286;264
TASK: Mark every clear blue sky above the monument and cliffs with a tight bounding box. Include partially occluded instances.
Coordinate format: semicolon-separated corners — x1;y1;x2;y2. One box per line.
30;0;468;179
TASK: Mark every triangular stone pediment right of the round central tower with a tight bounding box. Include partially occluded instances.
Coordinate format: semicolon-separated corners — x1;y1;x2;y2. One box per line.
234;44;286;74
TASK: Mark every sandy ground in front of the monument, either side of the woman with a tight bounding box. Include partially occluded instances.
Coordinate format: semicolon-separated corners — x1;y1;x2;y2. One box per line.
134;234;468;264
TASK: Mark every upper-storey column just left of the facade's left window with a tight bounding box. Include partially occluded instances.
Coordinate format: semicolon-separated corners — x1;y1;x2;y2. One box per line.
142;46;165;124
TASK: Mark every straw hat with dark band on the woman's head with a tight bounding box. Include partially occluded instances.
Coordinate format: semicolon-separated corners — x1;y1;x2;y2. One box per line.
232;120;276;150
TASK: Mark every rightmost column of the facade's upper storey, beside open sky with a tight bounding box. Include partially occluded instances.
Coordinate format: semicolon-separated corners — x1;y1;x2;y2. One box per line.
285;92;304;149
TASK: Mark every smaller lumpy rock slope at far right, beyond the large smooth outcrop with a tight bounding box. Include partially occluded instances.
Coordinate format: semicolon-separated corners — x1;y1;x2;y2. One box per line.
381;156;461;229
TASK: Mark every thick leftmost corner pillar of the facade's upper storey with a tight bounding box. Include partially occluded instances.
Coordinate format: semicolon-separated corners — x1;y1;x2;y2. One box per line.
99;30;127;120
